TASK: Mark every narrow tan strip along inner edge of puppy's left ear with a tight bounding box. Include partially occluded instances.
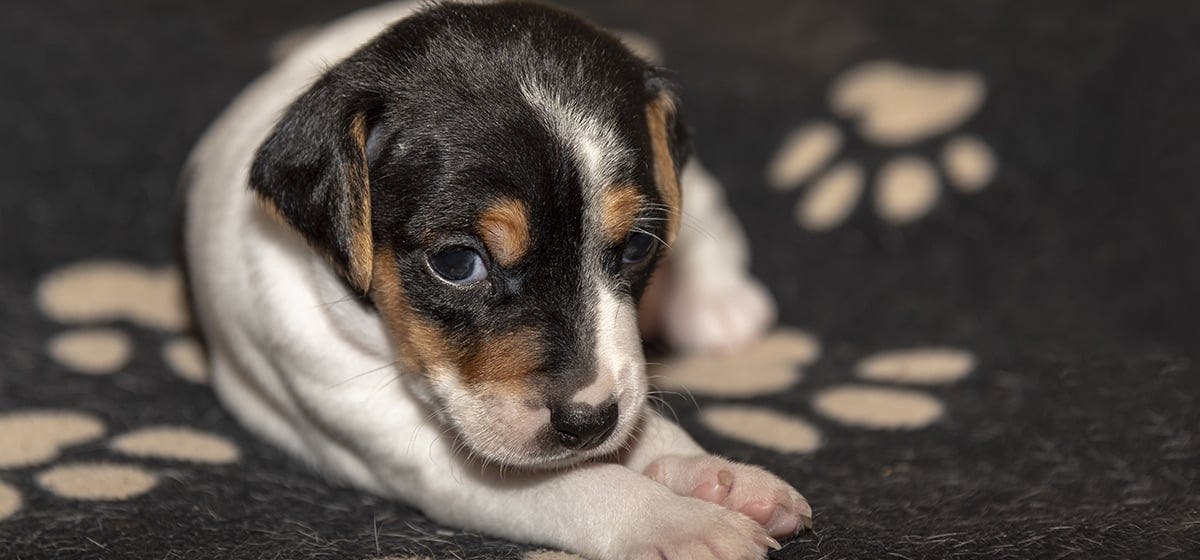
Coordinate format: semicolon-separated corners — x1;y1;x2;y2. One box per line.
346;113;374;293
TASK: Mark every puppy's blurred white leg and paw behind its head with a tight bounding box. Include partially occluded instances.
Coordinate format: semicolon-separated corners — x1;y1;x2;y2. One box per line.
643;159;775;351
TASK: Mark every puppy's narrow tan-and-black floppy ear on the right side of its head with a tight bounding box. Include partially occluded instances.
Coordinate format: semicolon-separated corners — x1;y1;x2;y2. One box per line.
646;68;691;246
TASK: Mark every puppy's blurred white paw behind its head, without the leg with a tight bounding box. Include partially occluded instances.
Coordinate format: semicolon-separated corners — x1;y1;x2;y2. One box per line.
664;272;775;353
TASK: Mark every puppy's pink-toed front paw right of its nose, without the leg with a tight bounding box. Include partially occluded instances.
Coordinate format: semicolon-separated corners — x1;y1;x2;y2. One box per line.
644;454;812;537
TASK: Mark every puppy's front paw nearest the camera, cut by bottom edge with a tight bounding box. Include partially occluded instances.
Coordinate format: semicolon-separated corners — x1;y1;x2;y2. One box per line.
613;494;779;560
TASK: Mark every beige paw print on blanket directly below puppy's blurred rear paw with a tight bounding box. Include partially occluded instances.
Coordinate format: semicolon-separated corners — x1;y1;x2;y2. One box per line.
654;330;976;453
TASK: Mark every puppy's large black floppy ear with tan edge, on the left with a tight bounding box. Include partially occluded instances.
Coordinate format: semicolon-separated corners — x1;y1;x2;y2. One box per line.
250;74;374;293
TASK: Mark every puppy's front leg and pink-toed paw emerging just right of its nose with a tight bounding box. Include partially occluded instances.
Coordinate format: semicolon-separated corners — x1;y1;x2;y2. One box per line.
624;413;812;537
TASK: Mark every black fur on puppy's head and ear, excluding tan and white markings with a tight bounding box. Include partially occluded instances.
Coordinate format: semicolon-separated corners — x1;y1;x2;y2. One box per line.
252;2;689;398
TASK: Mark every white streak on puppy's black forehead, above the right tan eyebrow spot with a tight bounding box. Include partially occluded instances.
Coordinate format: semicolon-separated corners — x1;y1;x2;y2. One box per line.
521;79;631;193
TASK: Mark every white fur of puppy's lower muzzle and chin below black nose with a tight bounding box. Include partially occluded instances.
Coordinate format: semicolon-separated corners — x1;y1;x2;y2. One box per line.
410;377;647;470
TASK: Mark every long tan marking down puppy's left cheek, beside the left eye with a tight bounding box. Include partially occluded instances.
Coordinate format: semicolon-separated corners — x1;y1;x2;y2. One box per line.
371;248;460;373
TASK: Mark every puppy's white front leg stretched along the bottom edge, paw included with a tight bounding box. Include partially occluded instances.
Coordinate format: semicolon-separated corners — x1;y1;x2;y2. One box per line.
419;463;779;560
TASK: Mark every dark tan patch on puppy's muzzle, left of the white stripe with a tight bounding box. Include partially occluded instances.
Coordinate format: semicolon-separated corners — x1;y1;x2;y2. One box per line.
462;327;542;385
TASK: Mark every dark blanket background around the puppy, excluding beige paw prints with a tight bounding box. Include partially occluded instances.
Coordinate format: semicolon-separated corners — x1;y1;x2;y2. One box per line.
0;0;1200;558
